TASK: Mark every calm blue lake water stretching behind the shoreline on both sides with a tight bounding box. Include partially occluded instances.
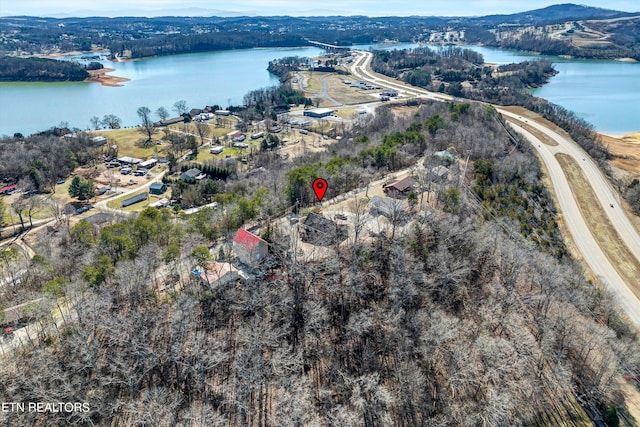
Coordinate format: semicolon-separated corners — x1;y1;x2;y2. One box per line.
0;44;640;135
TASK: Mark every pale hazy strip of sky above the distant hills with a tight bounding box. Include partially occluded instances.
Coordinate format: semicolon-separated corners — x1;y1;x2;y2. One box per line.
0;0;640;17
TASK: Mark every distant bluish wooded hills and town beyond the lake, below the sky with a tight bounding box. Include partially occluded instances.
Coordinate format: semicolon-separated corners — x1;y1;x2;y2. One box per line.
0;4;638;58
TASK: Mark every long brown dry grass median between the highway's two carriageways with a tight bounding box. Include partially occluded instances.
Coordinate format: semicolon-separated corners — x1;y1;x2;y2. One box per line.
556;153;640;298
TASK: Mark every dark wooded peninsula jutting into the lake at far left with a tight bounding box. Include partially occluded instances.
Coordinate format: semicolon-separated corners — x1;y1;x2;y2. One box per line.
0;56;89;82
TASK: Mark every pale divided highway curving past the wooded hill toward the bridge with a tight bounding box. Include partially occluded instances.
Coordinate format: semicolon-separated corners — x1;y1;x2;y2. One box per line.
350;51;640;327
